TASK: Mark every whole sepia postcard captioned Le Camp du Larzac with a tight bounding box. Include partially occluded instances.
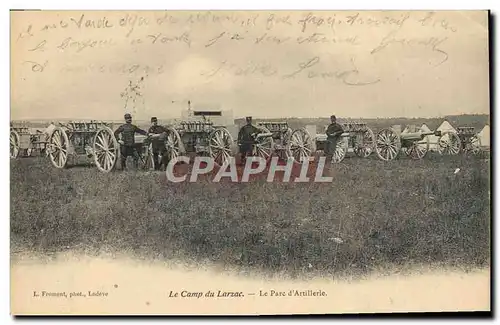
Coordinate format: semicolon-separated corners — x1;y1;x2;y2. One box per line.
10;10;491;315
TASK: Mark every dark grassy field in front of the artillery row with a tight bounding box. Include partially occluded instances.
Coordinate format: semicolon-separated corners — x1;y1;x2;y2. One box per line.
11;156;490;277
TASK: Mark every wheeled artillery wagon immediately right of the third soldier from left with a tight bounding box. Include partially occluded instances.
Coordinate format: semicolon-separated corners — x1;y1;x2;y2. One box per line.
252;121;314;162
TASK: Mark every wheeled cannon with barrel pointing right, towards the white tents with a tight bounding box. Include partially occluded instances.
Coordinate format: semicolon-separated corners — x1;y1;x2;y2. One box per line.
375;124;453;161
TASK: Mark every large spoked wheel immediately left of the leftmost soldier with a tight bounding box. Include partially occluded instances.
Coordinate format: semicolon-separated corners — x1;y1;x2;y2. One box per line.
92;127;120;173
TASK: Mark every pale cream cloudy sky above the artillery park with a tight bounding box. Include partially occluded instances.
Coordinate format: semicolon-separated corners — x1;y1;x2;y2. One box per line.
11;11;489;120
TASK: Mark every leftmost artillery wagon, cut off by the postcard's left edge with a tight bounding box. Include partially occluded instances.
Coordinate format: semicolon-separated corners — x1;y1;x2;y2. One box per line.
9;123;47;159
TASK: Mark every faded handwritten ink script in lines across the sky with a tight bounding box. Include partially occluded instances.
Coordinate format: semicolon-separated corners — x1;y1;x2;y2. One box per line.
13;11;460;86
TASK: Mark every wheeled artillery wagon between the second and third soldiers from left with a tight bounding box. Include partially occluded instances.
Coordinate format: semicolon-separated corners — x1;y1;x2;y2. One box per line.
163;111;234;166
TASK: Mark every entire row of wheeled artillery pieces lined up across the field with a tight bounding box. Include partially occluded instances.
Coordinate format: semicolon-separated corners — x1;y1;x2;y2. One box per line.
10;117;481;172
